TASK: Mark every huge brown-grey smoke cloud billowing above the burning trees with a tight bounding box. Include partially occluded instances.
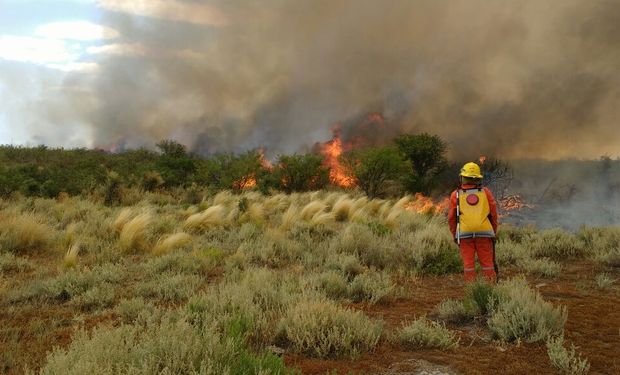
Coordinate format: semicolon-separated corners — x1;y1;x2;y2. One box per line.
3;0;620;159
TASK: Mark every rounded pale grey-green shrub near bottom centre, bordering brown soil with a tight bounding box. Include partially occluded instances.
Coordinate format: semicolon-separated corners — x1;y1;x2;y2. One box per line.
278;300;382;358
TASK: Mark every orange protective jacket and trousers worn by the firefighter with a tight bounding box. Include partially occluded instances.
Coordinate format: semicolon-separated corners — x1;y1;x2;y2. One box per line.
448;185;498;282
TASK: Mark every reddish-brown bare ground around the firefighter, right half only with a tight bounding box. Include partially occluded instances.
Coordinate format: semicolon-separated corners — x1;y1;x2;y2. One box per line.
285;262;620;374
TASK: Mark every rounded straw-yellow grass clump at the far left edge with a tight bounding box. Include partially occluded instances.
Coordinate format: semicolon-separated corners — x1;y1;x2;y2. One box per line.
0;214;54;254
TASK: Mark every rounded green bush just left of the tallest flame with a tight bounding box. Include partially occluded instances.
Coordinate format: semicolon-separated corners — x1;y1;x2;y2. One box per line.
273;154;329;193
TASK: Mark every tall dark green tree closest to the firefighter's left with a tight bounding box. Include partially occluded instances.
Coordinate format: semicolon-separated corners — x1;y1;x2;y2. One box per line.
394;133;448;194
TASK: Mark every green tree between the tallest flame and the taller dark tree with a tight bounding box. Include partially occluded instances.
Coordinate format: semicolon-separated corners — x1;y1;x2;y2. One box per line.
342;146;407;198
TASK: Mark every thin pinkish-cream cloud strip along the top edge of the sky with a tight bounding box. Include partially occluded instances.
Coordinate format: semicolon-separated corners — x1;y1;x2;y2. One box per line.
97;0;226;26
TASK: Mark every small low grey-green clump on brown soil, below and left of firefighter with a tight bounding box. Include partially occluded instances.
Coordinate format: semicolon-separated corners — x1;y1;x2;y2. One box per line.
397;317;459;350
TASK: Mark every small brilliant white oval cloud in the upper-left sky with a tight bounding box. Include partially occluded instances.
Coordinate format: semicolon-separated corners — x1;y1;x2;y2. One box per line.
35;21;120;41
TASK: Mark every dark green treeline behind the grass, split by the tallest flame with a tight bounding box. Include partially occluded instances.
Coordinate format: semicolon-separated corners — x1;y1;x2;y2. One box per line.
0;134;456;203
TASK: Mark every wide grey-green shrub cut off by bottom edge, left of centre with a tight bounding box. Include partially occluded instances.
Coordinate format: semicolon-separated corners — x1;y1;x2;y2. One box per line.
39;316;298;375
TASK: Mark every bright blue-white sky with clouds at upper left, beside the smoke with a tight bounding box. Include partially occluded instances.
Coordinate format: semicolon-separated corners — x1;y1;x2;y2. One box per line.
0;0;221;147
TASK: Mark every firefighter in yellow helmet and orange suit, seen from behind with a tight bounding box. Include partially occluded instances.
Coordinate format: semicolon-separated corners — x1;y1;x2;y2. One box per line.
448;163;498;283
